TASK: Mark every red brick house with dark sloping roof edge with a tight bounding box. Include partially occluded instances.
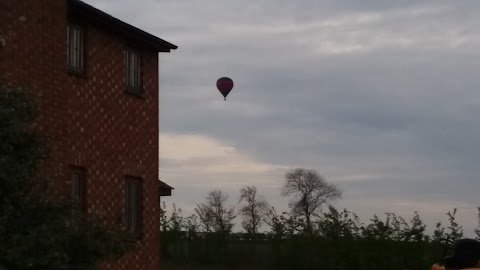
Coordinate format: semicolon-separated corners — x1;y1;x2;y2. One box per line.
0;0;177;270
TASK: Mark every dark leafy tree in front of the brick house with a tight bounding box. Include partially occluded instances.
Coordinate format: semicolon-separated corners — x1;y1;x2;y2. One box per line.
0;82;133;270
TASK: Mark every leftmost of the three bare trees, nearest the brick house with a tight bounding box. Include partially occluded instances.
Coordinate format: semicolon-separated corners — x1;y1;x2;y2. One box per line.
195;190;235;234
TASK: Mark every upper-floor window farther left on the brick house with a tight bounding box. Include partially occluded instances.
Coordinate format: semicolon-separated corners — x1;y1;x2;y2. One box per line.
67;25;84;73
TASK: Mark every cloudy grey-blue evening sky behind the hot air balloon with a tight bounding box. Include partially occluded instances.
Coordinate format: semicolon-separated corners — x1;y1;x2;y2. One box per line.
85;0;480;236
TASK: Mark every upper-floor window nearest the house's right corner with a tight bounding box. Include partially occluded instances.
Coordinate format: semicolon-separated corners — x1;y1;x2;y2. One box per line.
125;49;142;94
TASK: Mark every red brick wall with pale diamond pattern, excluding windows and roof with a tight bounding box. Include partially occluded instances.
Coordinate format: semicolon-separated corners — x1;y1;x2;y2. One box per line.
0;0;159;270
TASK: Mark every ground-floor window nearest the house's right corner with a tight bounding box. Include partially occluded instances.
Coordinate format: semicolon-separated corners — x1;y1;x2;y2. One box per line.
125;177;142;237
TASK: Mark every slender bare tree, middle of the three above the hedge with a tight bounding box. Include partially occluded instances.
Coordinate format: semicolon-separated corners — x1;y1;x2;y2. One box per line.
239;186;269;239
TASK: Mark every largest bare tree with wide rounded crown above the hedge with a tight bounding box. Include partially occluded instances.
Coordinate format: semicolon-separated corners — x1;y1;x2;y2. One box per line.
282;168;342;234
